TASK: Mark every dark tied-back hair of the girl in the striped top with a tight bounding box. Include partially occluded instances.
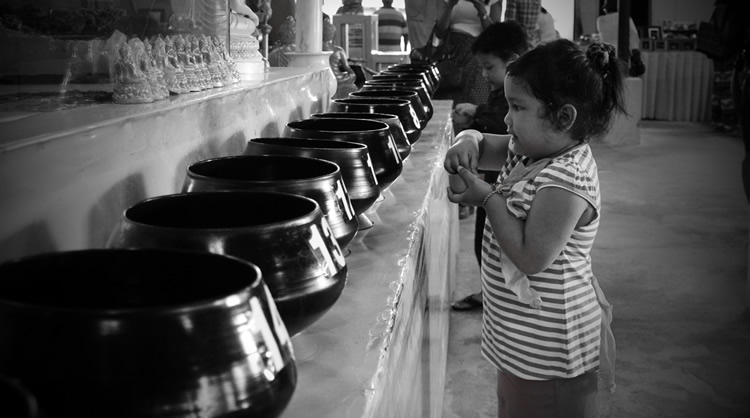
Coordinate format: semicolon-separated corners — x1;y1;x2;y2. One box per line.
507;39;626;141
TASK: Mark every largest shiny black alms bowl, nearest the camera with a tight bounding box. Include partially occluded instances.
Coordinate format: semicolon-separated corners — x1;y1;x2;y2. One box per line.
0;249;297;418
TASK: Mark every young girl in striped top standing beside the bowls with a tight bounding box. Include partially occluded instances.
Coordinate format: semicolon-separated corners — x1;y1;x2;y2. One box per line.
444;39;624;418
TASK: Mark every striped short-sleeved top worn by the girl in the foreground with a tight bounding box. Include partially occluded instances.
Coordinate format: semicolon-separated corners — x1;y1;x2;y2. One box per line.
481;143;602;380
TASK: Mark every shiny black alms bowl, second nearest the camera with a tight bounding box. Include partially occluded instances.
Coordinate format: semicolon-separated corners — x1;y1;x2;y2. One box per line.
109;191;347;335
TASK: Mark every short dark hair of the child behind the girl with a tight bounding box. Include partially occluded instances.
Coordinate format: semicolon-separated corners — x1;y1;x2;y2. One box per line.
471;20;528;62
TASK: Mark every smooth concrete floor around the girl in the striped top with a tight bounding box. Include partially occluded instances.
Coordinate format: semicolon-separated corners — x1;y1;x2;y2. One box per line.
443;121;750;418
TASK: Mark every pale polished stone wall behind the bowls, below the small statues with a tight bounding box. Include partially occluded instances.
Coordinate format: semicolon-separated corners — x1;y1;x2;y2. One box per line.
0;68;333;261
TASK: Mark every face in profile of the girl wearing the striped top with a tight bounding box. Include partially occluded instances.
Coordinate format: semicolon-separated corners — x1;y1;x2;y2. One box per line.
504;77;568;160
